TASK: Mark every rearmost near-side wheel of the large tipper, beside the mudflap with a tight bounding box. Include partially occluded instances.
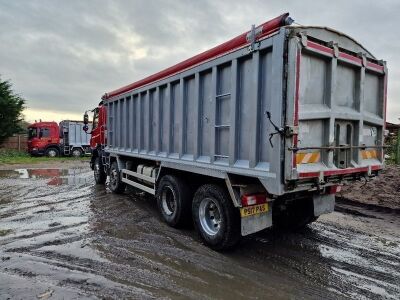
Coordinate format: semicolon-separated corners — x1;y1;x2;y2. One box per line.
192;184;240;250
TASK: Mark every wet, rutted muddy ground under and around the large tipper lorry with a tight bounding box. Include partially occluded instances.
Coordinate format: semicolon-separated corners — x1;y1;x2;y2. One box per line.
0;165;400;299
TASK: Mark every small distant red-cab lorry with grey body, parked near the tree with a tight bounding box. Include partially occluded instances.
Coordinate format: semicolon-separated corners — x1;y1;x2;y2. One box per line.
28;120;91;157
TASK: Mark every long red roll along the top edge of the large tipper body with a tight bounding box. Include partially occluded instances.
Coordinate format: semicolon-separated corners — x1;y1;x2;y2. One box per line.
103;13;293;100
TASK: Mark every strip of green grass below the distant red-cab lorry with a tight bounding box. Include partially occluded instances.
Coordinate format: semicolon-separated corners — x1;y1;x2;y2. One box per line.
0;149;89;164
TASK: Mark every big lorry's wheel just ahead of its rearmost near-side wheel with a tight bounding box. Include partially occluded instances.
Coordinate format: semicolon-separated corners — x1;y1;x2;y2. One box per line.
157;175;191;227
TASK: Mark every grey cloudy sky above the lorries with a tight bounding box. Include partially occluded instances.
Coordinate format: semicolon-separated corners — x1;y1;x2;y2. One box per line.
0;0;400;121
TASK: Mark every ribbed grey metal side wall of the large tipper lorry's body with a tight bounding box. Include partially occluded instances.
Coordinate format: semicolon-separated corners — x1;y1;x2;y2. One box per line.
107;30;284;195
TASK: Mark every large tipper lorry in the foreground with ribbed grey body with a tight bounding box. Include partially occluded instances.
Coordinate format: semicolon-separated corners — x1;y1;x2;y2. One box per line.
85;14;387;249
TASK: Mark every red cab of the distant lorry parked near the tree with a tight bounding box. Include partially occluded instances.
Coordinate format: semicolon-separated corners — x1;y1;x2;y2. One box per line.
28;122;60;157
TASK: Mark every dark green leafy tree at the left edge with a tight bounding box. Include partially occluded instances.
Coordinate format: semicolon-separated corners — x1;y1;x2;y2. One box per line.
0;78;25;145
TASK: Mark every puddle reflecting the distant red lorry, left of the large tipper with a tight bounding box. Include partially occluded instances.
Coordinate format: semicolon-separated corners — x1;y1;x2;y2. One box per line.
0;169;91;185
